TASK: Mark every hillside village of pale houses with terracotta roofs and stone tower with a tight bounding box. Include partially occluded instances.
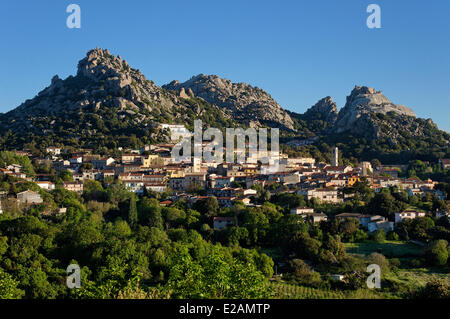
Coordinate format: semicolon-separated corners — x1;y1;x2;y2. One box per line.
0;126;450;232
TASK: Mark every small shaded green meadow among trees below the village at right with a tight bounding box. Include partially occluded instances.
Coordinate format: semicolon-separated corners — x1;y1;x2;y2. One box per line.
344;240;423;258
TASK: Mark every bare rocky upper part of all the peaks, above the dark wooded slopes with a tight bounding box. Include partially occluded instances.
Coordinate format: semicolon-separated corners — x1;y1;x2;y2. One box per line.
4;48;442;152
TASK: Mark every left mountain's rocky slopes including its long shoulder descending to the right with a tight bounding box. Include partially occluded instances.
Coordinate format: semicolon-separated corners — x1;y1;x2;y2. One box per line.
2;48;237;135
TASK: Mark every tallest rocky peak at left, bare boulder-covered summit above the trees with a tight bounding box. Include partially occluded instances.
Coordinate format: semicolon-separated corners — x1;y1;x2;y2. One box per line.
7;48;173;119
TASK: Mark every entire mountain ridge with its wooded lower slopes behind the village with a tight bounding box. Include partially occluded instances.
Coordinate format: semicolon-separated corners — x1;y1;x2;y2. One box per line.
0;48;450;162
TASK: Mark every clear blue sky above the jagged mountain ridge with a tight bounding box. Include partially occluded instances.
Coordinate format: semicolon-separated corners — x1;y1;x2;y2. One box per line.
0;0;450;131
